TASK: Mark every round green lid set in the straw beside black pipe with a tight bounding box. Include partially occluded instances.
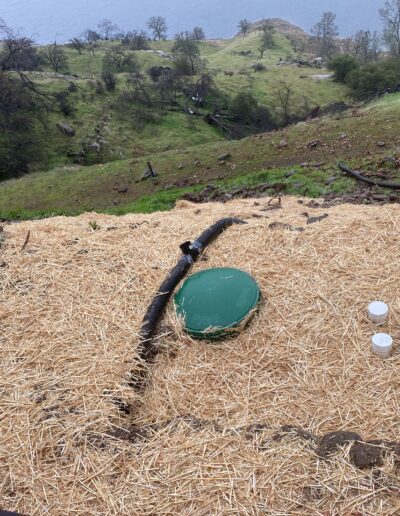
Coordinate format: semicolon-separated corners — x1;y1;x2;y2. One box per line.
174;268;261;339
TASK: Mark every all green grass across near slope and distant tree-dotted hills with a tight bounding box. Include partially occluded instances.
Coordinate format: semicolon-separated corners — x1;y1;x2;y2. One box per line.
6;29;394;218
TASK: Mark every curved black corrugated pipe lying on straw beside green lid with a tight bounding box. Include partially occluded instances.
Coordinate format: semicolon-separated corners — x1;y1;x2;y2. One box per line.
129;217;246;391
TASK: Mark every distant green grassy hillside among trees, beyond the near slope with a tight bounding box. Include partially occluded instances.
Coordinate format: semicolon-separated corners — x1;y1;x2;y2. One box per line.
22;33;347;168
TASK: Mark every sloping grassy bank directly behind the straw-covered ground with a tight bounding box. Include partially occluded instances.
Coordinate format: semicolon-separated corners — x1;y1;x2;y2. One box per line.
0;94;400;218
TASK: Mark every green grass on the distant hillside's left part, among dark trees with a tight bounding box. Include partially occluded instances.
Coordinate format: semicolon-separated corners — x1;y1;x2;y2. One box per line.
24;70;223;166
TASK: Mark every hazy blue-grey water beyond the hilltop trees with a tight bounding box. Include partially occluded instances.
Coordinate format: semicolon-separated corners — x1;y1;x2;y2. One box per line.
0;0;384;43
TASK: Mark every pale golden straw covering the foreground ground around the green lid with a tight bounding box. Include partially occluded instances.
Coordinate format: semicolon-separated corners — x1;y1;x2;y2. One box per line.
0;198;400;515
